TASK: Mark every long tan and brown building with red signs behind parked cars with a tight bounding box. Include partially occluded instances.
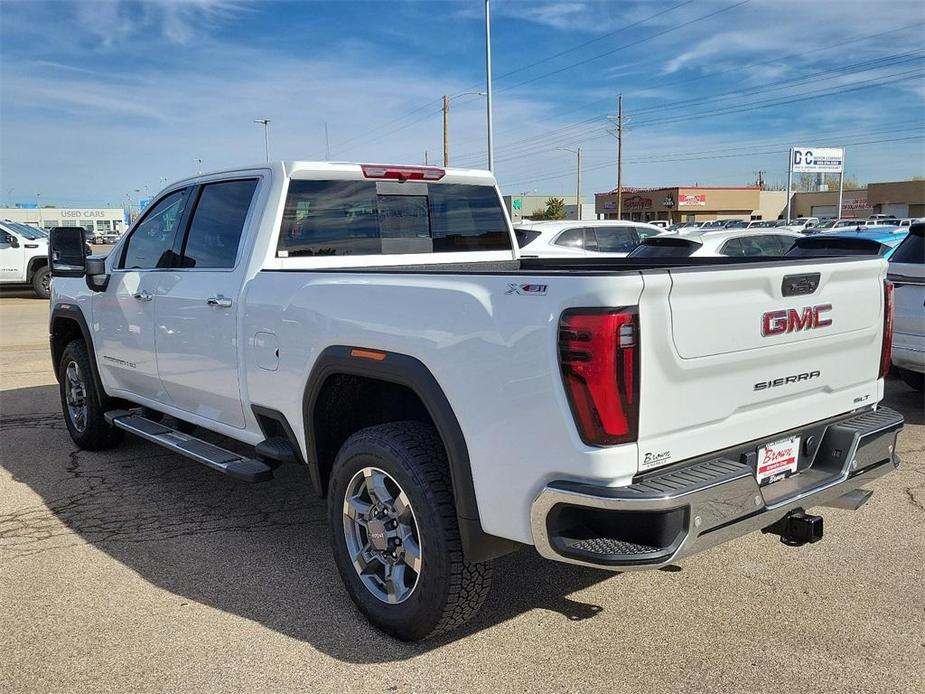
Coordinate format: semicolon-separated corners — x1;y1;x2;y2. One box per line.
594;186;787;222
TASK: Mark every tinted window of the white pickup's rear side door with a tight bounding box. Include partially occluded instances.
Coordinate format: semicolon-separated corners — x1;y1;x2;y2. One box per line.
180;179;257;269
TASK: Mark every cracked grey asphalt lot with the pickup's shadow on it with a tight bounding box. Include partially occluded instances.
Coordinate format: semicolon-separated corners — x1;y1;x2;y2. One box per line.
0;290;925;694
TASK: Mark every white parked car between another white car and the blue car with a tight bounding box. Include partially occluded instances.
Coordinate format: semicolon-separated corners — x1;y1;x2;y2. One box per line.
629;229;800;258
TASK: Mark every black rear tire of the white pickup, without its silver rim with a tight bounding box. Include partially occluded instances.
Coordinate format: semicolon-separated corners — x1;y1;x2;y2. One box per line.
328;421;492;641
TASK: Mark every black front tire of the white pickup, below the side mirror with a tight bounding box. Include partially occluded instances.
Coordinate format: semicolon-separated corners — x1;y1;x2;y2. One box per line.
58;340;124;451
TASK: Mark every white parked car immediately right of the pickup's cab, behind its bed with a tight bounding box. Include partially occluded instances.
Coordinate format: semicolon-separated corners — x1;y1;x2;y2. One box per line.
514;220;665;258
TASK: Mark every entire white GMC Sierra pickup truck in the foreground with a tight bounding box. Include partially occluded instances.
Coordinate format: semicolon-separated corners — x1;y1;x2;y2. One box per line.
50;162;903;640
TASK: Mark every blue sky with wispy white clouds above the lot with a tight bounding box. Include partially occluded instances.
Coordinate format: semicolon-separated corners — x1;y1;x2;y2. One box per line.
0;0;925;207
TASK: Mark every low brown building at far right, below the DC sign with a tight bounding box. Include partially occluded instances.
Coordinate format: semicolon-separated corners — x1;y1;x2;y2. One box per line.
790;180;925;219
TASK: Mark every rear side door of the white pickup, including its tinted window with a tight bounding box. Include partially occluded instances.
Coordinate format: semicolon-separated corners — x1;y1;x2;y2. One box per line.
155;178;258;428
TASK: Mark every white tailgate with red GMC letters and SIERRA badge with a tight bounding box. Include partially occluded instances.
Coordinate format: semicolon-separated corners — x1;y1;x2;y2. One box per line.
639;258;886;470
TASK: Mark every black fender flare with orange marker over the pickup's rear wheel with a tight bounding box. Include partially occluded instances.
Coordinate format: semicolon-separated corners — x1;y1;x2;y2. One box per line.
302;345;519;561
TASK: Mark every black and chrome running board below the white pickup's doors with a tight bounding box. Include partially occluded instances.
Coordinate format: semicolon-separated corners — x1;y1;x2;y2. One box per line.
104;410;273;482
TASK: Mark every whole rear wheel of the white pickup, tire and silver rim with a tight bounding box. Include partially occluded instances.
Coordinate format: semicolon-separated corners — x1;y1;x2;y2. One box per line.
328;422;492;641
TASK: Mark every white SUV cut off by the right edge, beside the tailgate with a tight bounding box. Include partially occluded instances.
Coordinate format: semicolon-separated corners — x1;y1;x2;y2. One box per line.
887;221;925;391
